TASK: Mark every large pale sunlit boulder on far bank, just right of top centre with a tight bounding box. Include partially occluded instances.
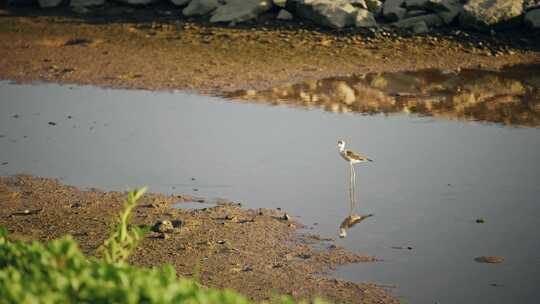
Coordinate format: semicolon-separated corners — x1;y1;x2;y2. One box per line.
288;0;356;29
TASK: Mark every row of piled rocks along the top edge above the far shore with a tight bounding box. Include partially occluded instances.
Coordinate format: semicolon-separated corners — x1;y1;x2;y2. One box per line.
8;0;540;34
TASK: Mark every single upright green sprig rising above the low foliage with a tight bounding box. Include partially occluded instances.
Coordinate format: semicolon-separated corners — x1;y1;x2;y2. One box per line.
98;187;146;264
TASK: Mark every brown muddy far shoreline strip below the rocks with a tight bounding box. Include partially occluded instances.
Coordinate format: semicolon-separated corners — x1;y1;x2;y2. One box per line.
0;6;540;95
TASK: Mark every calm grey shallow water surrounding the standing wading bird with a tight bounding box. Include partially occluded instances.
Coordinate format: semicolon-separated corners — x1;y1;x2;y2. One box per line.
0;76;540;303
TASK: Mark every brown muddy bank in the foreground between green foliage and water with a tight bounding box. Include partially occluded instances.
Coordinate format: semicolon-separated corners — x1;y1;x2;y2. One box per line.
0;175;398;303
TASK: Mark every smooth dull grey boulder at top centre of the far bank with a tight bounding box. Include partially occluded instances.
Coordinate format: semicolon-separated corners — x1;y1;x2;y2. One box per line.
210;0;272;23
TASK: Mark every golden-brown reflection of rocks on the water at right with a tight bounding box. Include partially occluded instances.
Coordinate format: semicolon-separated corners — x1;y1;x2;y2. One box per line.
231;67;540;126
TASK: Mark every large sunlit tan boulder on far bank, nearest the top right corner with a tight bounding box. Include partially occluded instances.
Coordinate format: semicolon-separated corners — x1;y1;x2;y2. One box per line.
459;0;523;31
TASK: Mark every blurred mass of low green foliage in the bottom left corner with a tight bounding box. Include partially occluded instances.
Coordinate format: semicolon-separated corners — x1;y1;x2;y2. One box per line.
0;229;253;304
